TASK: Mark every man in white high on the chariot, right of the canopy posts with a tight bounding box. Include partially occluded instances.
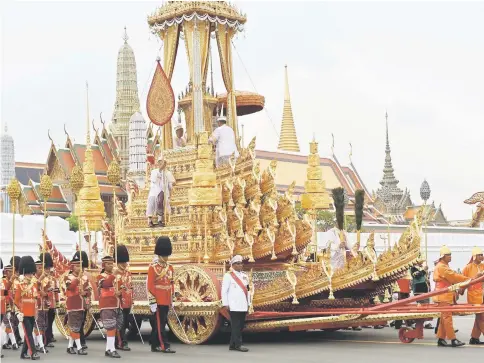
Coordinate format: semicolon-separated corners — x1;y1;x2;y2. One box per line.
208;106;239;167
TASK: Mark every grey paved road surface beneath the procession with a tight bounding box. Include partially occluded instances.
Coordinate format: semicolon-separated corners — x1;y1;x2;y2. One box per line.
2;318;484;363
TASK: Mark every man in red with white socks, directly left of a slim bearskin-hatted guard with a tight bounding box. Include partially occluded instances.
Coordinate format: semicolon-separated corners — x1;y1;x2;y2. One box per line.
97;256;121;358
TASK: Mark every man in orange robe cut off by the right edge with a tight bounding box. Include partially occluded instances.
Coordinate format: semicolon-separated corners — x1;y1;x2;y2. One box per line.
462;247;484;345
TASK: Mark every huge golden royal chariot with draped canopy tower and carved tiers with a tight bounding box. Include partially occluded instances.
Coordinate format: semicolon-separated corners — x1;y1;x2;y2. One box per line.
36;1;482;344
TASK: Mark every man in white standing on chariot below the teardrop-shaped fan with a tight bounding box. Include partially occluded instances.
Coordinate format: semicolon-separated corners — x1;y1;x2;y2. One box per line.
146;156;176;227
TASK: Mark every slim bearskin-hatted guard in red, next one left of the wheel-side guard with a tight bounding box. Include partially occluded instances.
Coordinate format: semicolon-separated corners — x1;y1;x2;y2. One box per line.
114;245;133;351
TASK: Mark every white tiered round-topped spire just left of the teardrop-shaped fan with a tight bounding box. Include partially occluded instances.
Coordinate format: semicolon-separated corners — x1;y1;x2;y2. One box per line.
128;111;147;189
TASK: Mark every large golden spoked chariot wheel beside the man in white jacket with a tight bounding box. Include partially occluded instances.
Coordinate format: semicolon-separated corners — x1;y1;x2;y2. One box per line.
168;265;222;344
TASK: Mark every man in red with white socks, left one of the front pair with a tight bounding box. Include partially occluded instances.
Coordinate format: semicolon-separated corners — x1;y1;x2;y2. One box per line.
64;255;87;355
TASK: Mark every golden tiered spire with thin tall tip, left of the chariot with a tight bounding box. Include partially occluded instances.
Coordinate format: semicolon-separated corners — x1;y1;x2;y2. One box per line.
77;83;106;231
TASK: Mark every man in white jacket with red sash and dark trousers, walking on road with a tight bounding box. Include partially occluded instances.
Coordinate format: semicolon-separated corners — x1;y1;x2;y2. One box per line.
222;255;252;352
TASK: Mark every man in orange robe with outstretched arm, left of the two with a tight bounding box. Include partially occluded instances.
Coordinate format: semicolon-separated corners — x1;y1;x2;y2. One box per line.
433;246;469;347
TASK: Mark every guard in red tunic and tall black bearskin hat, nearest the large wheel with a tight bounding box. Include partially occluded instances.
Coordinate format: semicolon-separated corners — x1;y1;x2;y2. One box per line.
147;236;175;353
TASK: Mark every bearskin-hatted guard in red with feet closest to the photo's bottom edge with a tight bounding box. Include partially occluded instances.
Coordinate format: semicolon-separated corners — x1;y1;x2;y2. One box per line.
14;256;40;360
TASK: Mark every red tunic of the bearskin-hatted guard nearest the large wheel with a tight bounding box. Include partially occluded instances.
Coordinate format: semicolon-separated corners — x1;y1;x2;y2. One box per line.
148;262;175;305
